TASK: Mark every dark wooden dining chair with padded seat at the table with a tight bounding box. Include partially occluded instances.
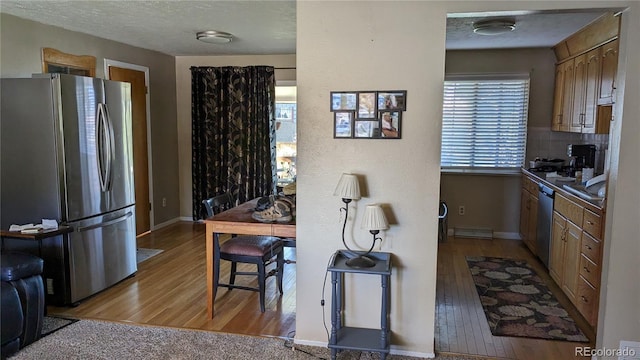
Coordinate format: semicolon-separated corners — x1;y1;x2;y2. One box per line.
202;193;284;312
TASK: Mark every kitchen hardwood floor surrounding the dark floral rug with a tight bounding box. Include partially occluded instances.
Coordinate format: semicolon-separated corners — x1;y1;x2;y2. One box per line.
435;237;595;360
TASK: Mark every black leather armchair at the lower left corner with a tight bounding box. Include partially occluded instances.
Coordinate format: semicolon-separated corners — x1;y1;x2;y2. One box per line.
0;252;45;359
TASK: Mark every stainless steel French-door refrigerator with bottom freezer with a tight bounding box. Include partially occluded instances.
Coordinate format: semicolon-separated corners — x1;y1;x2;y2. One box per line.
0;74;137;305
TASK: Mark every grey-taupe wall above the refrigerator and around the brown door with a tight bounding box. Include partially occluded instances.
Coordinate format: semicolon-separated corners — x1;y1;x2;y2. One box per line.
0;13;180;225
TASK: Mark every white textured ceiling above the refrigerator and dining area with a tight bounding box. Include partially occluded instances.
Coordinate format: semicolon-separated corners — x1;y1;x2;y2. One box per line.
0;0;296;56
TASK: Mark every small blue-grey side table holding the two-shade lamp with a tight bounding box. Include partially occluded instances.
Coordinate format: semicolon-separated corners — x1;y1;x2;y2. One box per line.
327;250;391;360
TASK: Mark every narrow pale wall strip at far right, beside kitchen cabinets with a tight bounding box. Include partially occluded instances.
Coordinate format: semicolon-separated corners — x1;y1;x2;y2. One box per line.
597;8;640;356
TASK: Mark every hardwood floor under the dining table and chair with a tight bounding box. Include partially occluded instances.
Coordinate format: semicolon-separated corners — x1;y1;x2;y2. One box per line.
47;222;296;337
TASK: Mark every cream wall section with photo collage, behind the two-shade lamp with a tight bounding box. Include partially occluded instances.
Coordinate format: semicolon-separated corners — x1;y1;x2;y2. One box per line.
296;1;445;355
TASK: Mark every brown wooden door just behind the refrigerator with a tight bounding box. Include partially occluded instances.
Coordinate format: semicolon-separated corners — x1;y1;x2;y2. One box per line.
105;60;153;236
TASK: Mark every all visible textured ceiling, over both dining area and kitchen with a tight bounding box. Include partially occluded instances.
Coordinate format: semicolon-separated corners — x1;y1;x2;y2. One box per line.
0;0;616;56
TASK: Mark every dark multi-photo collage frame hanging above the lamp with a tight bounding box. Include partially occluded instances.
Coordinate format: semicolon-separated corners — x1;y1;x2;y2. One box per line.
330;90;407;139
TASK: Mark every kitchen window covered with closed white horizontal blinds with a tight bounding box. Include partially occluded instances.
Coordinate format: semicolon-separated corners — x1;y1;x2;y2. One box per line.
441;74;529;170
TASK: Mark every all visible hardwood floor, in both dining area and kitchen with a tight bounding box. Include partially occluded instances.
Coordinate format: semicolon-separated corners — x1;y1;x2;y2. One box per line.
48;222;594;360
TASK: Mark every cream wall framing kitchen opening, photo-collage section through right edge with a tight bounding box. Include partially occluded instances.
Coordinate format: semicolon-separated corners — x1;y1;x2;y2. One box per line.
296;1;640;356
